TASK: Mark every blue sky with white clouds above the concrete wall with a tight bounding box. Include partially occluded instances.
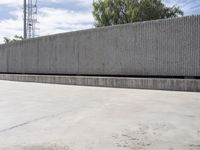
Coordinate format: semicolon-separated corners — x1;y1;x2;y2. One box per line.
0;0;200;43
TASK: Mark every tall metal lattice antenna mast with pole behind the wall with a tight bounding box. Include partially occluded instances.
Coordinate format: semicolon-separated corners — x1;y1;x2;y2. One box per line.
24;0;38;38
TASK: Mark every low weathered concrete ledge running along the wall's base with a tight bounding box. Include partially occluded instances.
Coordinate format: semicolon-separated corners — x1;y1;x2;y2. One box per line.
0;74;200;92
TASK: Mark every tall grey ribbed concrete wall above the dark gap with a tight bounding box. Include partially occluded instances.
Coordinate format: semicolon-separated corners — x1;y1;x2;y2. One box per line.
0;16;200;77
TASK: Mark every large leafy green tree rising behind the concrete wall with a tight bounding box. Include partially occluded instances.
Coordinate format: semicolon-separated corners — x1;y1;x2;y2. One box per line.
93;0;183;27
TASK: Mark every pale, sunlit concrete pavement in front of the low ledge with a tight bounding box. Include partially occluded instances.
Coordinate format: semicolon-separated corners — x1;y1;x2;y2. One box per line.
0;81;200;150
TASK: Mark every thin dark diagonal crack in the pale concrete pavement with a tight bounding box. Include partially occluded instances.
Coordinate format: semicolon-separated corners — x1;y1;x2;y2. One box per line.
0;111;69;134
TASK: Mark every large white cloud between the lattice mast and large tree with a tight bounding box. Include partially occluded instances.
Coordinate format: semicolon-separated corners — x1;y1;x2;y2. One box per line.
38;8;93;35
